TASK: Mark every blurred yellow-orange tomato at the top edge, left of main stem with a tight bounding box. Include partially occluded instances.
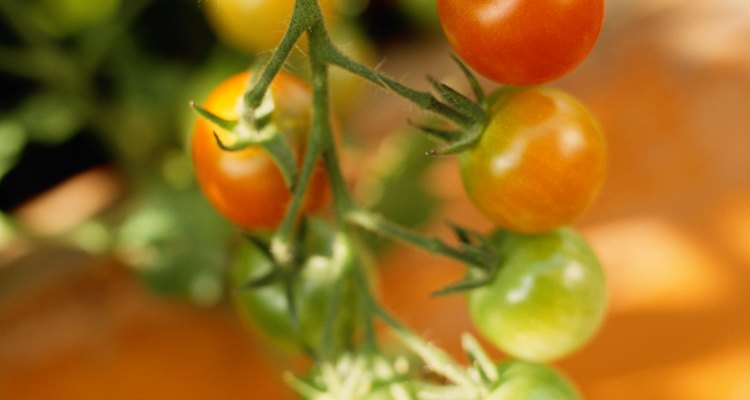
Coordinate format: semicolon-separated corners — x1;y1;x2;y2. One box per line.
204;0;335;54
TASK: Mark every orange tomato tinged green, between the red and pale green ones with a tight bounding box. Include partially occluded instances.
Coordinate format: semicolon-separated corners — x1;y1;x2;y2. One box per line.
461;87;607;232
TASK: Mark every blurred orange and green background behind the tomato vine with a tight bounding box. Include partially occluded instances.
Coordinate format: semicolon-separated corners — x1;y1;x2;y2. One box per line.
0;0;750;400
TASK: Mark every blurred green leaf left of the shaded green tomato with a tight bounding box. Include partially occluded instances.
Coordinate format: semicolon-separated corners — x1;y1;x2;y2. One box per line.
116;186;234;305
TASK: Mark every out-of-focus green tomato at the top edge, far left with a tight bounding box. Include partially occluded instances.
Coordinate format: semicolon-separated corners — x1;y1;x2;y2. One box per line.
31;0;120;36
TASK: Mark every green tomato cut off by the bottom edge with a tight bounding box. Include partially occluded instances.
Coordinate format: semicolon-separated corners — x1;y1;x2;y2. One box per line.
489;360;581;400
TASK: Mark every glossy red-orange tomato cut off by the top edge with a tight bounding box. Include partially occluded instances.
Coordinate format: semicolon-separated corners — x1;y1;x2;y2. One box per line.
437;0;604;86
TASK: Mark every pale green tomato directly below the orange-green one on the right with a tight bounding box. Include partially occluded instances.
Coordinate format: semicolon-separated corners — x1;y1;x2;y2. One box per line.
468;228;606;361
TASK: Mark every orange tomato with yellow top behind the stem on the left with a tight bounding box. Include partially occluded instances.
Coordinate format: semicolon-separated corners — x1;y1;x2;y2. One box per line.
192;72;329;230
